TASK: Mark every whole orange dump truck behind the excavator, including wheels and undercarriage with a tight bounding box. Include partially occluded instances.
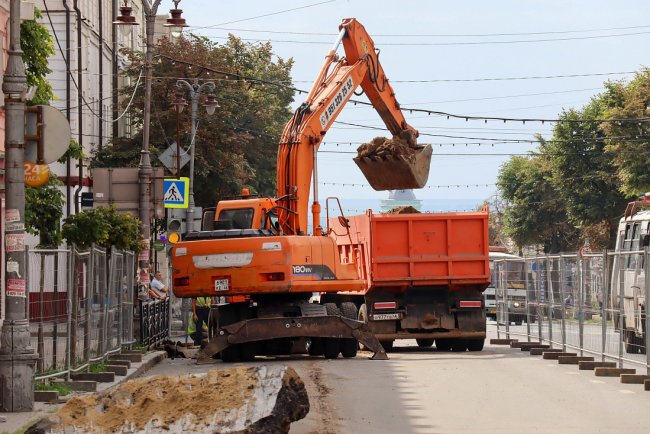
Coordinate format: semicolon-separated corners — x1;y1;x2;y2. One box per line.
321;211;490;351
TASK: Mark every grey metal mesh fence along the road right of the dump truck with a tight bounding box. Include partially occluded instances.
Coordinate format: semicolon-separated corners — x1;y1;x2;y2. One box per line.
492;247;650;375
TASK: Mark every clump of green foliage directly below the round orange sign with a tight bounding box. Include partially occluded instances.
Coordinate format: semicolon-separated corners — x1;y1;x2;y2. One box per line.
25;174;65;248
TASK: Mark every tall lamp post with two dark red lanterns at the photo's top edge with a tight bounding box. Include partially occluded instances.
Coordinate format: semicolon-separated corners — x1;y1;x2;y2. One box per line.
114;0;187;261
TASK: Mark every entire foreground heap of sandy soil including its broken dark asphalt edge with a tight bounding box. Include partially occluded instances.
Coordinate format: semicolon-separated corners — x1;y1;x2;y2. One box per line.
27;367;309;433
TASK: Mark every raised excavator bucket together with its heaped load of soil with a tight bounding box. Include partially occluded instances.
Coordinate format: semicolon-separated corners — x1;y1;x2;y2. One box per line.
354;131;433;191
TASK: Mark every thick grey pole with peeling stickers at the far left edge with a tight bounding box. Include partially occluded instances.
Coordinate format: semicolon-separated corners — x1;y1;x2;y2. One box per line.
0;0;37;412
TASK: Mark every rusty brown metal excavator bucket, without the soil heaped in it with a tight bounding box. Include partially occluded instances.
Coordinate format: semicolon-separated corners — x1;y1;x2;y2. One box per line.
354;145;433;191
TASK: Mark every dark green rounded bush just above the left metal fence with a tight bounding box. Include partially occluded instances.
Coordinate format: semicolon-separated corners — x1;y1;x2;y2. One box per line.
62;206;143;252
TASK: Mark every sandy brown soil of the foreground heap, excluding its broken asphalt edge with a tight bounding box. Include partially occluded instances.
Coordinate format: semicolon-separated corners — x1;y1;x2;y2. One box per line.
53;368;257;432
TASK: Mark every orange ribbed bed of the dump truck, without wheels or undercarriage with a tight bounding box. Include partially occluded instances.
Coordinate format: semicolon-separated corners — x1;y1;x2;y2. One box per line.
330;211;490;291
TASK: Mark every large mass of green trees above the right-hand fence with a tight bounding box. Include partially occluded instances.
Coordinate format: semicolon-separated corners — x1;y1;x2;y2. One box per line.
498;68;650;252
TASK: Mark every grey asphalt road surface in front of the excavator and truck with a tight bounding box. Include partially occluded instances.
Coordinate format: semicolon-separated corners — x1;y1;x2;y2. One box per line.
147;328;650;434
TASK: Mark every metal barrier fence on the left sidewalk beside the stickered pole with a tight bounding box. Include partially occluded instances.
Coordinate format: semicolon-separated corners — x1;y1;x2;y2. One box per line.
26;247;141;380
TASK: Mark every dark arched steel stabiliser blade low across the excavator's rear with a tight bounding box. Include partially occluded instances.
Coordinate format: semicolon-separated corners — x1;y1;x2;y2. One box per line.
197;315;388;364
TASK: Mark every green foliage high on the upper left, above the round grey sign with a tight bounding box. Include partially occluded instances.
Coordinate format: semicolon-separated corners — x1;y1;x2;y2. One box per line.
20;9;55;105
